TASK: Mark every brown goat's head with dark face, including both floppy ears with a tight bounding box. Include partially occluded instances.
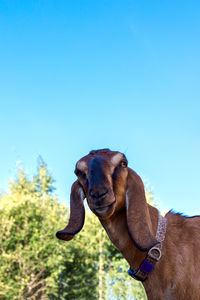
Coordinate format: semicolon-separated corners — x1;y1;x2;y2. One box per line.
56;149;157;251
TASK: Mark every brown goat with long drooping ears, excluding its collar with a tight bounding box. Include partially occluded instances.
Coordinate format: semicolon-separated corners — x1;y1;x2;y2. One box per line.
57;149;200;300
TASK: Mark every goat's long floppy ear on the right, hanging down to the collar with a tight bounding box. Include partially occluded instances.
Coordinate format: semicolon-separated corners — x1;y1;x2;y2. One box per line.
126;169;158;251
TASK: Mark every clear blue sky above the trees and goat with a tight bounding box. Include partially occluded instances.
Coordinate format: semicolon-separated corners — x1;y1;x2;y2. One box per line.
0;0;200;215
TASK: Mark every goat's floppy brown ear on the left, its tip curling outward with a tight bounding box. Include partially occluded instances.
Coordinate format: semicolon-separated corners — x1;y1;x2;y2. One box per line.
56;180;85;241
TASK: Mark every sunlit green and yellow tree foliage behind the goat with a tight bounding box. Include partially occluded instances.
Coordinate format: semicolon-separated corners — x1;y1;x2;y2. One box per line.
0;158;151;300
